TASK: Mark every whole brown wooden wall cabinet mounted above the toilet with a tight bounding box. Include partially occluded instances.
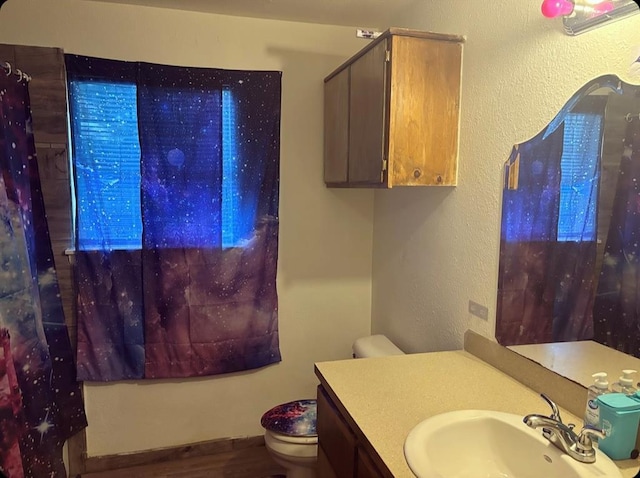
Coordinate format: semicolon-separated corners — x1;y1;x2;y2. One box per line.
324;28;464;188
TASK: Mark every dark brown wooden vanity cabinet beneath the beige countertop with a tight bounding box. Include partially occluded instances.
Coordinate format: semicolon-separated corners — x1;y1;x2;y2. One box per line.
317;386;393;478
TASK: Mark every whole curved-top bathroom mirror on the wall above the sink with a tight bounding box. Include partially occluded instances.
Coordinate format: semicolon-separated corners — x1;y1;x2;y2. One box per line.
496;75;640;357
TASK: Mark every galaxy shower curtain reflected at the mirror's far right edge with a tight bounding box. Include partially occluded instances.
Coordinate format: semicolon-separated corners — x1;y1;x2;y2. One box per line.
593;116;640;357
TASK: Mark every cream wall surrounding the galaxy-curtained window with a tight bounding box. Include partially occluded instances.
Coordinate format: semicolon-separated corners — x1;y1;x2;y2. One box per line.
0;0;373;456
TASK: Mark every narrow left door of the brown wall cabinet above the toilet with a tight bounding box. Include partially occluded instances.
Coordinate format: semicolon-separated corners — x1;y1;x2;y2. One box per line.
324;68;349;183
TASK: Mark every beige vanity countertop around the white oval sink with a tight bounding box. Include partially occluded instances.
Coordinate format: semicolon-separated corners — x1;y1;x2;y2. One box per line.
316;351;638;478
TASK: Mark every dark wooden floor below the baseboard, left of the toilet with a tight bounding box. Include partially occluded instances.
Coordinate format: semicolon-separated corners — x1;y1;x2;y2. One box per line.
81;447;284;478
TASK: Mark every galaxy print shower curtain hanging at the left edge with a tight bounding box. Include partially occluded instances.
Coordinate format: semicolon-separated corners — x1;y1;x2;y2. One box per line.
0;65;87;478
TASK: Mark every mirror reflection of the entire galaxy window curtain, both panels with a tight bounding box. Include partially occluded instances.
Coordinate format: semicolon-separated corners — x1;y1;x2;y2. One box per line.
496;98;606;345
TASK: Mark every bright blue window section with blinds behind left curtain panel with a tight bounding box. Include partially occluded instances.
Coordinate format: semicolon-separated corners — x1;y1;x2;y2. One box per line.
69;81;142;250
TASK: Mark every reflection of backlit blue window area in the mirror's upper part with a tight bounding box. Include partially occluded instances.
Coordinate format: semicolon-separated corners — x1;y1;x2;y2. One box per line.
501;107;604;243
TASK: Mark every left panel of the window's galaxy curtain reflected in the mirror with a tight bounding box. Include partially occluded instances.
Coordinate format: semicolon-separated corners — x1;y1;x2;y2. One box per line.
496;127;564;345
